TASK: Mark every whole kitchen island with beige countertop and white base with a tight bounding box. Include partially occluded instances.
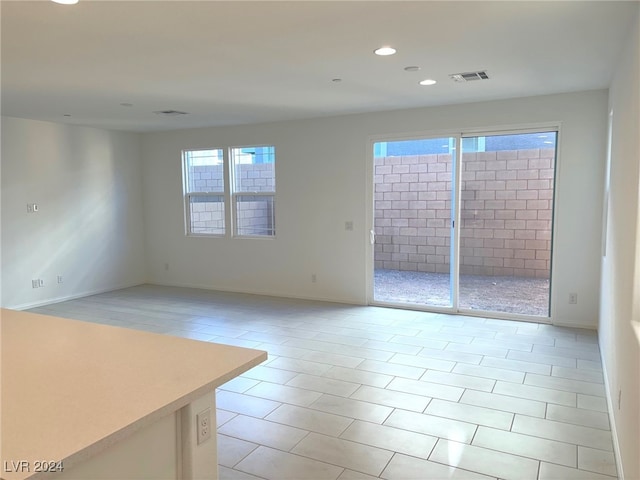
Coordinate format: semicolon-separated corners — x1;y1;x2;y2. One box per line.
0;309;267;480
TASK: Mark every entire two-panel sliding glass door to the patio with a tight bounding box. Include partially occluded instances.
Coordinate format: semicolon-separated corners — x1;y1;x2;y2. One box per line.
372;129;557;317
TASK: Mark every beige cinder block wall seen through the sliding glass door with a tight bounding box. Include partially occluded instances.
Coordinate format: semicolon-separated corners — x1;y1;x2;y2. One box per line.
374;149;555;278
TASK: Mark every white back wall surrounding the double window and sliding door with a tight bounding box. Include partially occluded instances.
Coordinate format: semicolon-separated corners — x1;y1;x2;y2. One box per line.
142;91;607;328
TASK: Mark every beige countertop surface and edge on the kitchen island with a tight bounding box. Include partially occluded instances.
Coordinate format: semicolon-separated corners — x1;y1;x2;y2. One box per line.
0;309;267;480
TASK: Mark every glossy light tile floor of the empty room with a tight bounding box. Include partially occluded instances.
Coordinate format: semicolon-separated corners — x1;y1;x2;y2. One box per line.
27;285;617;480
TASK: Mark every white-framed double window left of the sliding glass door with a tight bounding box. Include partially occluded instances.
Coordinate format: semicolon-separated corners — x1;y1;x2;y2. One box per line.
182;146;275;237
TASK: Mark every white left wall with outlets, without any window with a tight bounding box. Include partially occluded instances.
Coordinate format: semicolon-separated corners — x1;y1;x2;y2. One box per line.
1;117;146;308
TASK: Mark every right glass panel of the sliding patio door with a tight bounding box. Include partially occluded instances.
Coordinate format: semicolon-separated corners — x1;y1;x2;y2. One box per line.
459;131;557;317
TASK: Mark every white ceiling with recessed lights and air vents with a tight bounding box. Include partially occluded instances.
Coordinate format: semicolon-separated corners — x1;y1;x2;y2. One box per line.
0;0;640;132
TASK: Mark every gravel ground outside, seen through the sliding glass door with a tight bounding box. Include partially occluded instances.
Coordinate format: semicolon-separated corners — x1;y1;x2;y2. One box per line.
374;269;549;317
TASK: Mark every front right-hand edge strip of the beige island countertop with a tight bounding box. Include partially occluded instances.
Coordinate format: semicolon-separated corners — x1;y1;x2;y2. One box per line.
15;351;267;480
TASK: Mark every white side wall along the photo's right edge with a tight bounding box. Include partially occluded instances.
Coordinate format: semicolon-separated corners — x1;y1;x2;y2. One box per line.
599;5;640;479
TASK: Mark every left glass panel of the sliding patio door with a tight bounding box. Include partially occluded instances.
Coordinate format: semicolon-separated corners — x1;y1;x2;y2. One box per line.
374;137;457;307
